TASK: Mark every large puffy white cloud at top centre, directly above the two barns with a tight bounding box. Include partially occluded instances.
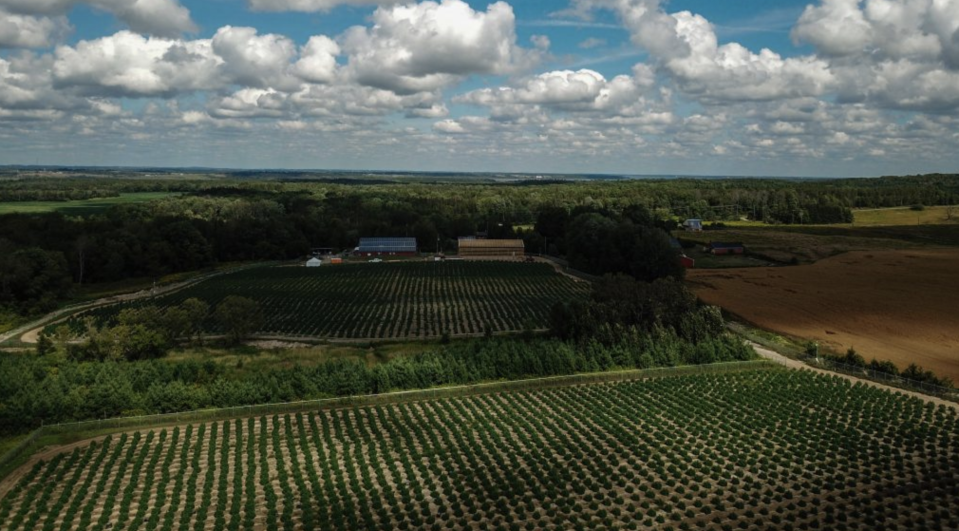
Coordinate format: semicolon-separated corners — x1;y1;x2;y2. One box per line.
341;0;537;94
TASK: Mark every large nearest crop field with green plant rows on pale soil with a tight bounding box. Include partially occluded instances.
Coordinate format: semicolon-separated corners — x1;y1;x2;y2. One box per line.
0;369;959;531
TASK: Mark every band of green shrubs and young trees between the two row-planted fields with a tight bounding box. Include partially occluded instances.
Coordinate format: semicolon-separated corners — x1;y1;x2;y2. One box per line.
0;332;752;432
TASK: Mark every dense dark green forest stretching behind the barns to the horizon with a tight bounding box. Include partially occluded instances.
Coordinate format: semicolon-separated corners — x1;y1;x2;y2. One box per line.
0;175;959;315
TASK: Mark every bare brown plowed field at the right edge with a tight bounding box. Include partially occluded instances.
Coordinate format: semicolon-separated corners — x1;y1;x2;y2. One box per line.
687;249;959;383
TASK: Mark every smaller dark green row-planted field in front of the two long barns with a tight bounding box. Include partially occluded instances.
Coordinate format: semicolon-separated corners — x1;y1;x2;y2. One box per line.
63;261;589;339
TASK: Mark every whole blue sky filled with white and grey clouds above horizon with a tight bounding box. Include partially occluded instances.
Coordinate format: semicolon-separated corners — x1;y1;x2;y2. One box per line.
0;0;959;177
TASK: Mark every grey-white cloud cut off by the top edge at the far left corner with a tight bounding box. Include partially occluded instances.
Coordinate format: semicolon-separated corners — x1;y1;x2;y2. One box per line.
0;0;198;37
